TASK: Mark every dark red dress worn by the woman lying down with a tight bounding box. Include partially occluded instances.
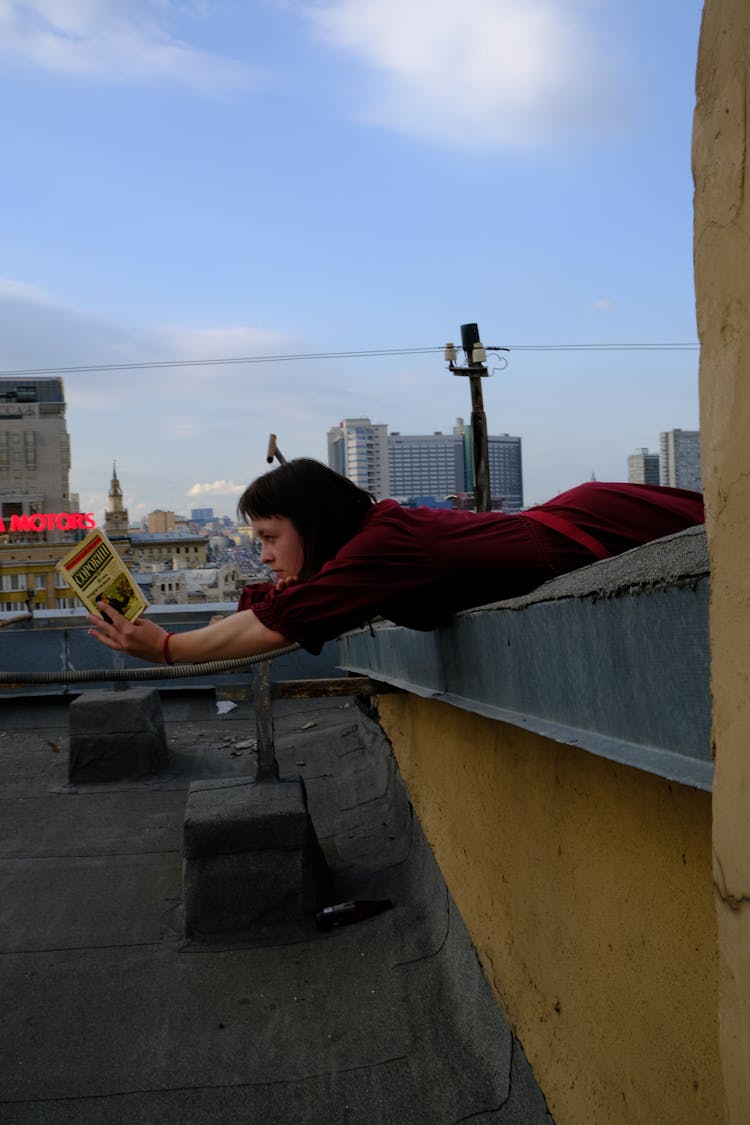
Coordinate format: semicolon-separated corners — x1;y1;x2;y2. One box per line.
238;480;703;653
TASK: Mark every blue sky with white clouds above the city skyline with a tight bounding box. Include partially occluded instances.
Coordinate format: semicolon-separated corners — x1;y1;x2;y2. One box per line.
0;0;702;520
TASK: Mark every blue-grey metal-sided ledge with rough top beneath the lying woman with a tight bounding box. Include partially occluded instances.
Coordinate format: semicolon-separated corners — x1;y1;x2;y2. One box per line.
340;528;713;790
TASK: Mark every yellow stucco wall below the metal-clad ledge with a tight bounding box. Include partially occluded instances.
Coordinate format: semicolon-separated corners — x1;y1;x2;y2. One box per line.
379;694;723;1125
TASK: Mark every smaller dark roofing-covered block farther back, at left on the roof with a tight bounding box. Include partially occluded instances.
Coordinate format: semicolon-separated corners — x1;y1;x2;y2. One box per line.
67;687;169;783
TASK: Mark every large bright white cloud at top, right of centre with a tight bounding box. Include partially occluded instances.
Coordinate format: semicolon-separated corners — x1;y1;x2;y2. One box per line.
310;0;621;147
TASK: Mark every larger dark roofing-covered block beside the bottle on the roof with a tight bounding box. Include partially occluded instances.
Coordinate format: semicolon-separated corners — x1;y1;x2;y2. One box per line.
182;779;326;937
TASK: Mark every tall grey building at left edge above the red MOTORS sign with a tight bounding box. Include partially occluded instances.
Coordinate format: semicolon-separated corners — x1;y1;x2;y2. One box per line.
0;378;71;528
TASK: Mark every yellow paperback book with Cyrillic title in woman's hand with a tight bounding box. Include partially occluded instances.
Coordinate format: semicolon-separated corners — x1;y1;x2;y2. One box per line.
57;528;148;621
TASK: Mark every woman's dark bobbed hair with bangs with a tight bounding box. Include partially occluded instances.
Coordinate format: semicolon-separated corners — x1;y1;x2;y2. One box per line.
237;457;374;578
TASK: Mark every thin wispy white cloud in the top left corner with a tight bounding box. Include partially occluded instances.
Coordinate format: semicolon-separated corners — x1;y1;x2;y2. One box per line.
0;0;252;89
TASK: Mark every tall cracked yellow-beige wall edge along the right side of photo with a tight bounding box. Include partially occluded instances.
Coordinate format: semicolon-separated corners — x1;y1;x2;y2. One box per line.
693;0;750;1125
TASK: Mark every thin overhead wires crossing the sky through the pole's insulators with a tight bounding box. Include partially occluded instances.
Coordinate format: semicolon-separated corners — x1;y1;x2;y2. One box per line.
0;342;699;378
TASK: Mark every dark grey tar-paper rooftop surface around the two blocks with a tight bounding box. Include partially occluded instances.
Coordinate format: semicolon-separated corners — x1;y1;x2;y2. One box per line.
0;691;551;1125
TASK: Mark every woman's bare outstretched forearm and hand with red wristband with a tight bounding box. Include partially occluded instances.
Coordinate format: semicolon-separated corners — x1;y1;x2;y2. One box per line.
88;602;290;664
